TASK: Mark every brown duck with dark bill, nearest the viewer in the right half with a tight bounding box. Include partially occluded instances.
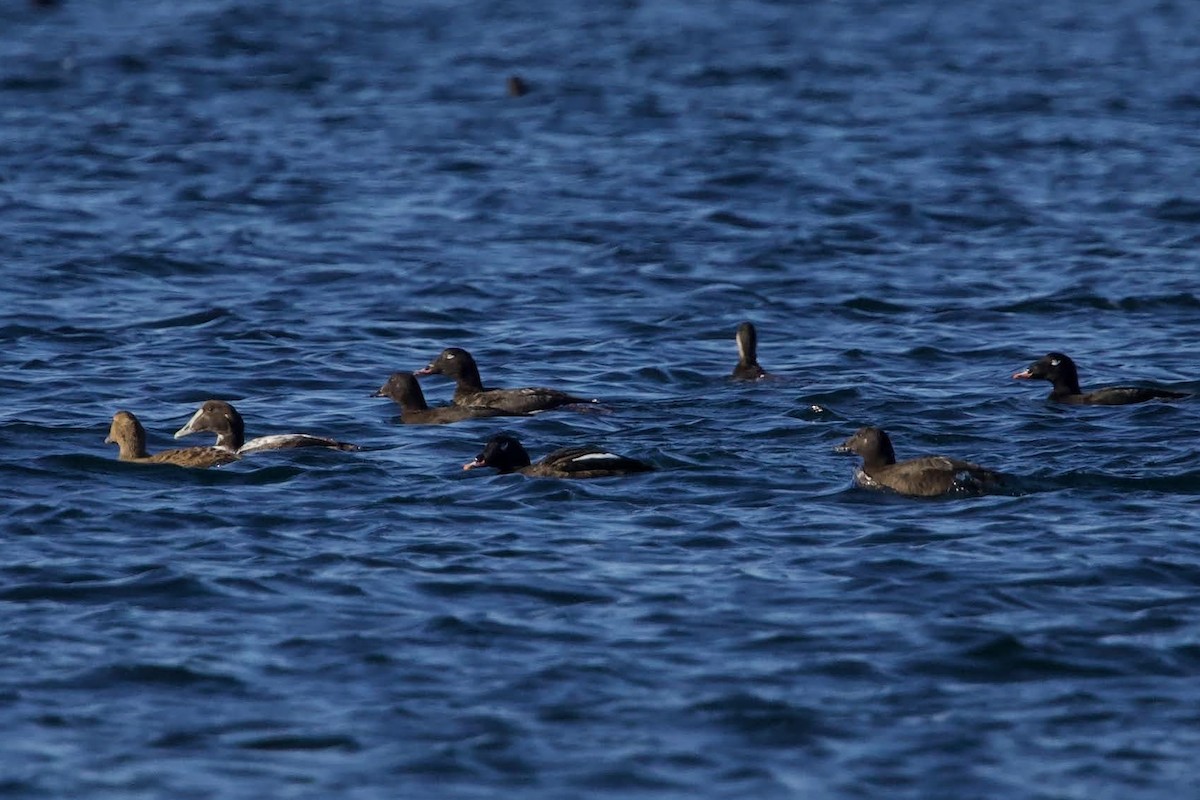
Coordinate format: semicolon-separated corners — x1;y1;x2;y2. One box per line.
834;426;1002;498
